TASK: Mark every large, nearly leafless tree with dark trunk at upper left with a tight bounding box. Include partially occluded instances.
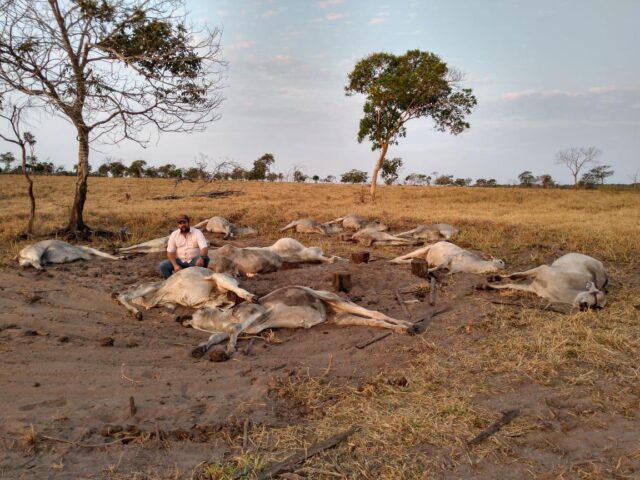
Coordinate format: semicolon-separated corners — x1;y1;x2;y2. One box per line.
0;0;222;233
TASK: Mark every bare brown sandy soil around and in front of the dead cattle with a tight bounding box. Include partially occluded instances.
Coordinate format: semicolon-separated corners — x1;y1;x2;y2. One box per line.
0;232;640;478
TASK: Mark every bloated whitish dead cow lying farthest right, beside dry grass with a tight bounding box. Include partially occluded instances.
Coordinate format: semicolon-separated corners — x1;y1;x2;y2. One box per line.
489;253;609;311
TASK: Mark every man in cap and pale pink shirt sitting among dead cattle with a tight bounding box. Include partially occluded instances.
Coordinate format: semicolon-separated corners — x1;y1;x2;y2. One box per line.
160;214;209;278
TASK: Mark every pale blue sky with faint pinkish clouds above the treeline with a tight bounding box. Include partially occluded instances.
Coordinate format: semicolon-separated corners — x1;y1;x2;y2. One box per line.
6;0;640;182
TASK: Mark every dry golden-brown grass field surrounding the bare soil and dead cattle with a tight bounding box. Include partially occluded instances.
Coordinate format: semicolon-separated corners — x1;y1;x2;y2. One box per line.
0;176;640;479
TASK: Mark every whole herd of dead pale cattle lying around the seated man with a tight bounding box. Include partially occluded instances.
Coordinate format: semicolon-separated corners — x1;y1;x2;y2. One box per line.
13;215;608;358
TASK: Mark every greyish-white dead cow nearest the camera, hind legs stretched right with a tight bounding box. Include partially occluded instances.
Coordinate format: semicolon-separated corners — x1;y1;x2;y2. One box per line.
182;286;413;357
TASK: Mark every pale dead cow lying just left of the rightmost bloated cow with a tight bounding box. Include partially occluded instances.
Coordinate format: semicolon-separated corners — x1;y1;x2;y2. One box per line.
391;242;504;273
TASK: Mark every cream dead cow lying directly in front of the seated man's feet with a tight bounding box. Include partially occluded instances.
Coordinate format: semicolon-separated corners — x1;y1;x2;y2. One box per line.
115;267;256;319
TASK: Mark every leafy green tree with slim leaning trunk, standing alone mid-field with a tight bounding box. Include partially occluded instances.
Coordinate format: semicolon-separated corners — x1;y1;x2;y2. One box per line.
345;50;477;198
